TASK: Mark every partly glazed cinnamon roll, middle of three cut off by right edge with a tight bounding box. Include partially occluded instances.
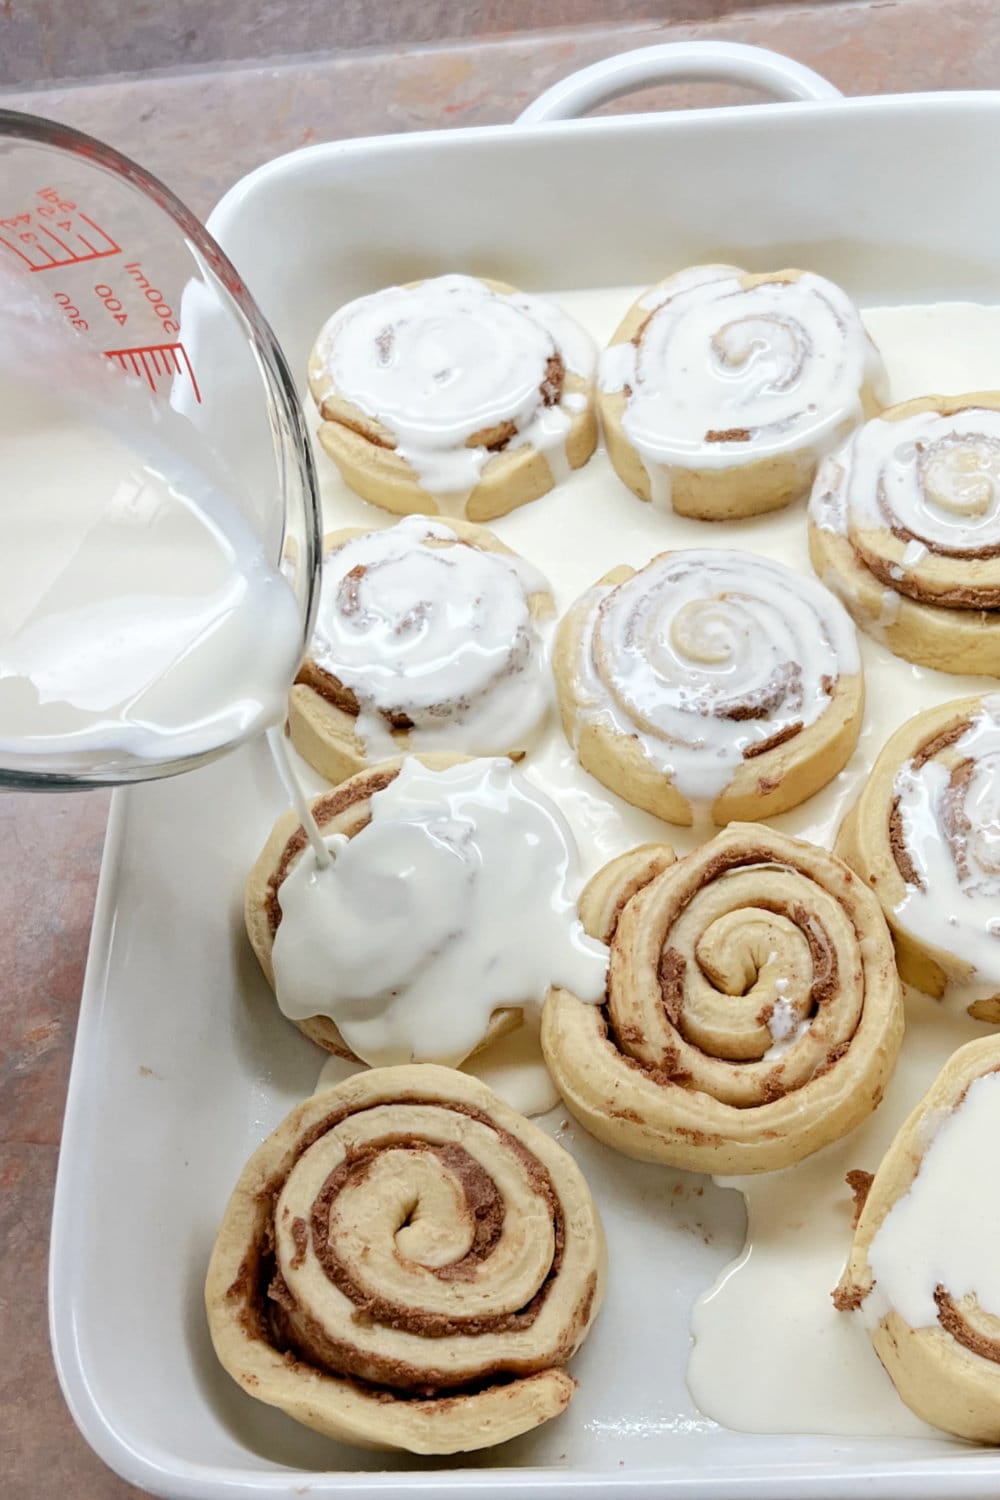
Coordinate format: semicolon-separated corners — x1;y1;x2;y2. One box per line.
837;695;1000;1023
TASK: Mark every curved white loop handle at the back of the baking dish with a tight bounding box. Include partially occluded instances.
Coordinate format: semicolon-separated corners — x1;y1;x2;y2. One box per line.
516;42;843;125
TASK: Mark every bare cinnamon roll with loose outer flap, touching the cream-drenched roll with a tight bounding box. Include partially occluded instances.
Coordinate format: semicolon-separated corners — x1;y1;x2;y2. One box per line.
541;824;903;1173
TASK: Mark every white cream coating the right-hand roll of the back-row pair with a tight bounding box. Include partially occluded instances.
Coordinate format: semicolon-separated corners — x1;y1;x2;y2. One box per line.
600;266;885;483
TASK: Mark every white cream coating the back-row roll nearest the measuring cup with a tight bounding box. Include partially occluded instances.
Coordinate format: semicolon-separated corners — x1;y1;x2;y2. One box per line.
316;276;597;515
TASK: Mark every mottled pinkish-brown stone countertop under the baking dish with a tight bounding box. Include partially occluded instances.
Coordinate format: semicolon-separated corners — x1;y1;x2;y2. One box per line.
0;0;1000;1500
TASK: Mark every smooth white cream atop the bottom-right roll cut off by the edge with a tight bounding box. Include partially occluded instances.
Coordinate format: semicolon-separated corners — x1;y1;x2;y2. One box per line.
862;1073;1000;1328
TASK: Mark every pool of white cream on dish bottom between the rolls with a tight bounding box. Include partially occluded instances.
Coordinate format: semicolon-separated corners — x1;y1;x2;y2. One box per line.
301;288;1000;1436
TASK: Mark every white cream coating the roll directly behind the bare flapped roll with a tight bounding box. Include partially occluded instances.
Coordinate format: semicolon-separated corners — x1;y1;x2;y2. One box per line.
577;549;861;804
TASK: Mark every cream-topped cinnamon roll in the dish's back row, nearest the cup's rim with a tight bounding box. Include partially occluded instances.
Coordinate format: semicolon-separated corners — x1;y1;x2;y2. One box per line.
309;276;597;521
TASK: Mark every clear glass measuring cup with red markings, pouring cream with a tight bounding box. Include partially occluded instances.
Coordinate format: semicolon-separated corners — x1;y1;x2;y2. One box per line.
0;110;321;789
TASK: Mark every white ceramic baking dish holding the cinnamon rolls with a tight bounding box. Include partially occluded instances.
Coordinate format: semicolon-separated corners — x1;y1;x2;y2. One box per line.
51;44;1000;1500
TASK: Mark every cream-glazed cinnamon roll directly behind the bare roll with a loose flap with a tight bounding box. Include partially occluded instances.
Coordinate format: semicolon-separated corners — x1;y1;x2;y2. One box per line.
553;551;864;825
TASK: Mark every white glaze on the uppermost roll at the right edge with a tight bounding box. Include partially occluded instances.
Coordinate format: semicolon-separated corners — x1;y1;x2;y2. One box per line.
810;407;1000;573
